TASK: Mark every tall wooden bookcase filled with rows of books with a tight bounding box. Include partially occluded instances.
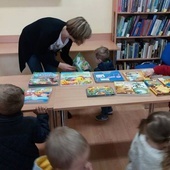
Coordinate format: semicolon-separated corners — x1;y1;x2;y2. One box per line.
112;0;170;69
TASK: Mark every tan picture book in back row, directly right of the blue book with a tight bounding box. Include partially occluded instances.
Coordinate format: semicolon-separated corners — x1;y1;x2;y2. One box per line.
122;70;149;81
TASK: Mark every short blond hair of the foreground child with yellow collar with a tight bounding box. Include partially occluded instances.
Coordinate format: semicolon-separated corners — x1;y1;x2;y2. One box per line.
46;127;89;169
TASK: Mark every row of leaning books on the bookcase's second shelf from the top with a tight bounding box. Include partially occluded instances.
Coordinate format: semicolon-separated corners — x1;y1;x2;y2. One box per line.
117;15;170;37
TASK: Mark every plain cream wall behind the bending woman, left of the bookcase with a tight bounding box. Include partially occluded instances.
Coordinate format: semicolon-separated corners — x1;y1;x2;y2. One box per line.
0;0;112;35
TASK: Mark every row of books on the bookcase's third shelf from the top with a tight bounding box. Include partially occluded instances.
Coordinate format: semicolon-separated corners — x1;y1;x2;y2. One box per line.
117;39;167;60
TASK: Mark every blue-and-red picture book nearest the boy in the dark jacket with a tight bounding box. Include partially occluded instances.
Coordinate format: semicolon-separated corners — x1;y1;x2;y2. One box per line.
24;87;52;103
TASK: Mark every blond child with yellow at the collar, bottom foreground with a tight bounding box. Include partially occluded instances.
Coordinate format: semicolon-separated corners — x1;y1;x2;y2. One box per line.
33;127;93;170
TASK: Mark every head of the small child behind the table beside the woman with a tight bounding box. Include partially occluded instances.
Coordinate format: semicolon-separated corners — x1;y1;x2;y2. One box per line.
95;46;110;62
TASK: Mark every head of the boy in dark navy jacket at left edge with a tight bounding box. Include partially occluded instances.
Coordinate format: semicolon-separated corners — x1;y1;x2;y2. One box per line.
0;84;24;115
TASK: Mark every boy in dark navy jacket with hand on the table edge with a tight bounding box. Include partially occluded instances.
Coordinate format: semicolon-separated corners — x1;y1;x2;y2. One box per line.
0;84;49;170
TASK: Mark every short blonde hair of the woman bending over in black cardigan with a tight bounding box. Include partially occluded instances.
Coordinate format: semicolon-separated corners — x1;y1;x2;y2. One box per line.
66;17;92;44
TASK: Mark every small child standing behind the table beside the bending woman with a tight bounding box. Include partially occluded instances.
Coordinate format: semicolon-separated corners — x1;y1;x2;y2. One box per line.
94;47;114;121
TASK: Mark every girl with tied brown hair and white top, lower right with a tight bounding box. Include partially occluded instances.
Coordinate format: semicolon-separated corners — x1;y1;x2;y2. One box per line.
126;111;170;170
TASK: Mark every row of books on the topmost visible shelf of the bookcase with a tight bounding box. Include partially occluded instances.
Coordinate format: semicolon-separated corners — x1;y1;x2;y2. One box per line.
118;0;170;12
